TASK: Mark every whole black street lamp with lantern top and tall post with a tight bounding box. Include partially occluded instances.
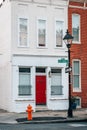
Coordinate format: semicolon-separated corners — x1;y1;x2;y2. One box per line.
63;30;73;117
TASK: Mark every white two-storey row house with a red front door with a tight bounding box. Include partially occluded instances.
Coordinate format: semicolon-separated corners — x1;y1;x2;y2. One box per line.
0;0;68;112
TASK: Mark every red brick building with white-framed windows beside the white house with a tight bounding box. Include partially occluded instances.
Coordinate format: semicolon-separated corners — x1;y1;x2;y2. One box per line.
68;0;87;108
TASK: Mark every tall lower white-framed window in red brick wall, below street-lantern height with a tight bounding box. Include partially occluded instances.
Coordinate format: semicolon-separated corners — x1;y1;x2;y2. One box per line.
73;60;81;90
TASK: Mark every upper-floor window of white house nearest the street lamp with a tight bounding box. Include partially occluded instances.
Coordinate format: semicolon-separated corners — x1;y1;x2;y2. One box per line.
56;21;63;47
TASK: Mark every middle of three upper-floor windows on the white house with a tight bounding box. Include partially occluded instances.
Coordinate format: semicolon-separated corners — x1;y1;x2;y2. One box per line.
38;19;46;47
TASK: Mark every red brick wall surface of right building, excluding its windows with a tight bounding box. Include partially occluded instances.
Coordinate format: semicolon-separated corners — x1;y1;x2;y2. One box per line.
68;2;87;108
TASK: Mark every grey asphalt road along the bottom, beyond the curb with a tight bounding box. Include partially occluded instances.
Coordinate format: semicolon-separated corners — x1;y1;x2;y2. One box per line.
0;122;87;130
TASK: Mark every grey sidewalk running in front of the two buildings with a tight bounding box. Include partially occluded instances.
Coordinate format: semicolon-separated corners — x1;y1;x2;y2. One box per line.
0;109;87;124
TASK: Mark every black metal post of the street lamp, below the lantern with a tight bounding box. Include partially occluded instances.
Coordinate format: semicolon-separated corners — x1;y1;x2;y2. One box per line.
68;48;73;117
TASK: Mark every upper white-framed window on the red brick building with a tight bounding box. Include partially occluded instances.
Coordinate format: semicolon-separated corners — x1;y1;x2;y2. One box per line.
72;14;80;42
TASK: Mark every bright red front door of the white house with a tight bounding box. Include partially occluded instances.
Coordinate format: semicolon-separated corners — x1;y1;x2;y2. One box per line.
36;76;46;105
